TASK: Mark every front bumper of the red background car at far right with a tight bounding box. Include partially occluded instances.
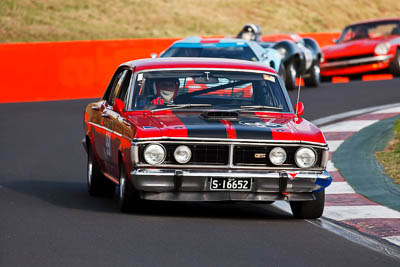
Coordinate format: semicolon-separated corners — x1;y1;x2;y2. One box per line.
321;55;393;76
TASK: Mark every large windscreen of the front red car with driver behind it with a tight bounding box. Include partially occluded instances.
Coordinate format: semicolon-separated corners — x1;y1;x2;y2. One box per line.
130;70;290;112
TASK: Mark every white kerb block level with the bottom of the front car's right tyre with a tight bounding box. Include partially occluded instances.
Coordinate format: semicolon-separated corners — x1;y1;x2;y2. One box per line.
323;205;400;221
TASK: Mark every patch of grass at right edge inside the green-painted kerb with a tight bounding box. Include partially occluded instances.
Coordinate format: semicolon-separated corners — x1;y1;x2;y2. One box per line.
376;119;400;184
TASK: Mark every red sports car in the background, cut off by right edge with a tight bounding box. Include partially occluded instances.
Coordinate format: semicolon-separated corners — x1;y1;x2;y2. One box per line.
321;19;400;77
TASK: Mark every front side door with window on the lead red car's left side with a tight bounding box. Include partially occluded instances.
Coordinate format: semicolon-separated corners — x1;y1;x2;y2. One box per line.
102;69;131;179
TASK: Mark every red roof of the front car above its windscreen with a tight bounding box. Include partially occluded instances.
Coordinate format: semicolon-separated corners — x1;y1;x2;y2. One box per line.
121;57;276;74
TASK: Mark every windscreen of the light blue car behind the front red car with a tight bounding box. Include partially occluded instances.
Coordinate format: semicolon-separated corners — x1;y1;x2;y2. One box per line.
161;45;258;61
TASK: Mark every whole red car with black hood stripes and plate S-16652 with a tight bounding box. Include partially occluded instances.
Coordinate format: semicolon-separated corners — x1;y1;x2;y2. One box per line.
82;58;332;218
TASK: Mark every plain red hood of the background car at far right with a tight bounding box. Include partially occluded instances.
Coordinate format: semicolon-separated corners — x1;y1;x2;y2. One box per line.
322;38;392;58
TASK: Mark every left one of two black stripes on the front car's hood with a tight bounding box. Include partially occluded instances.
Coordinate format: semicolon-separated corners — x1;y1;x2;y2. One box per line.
175;113;227;138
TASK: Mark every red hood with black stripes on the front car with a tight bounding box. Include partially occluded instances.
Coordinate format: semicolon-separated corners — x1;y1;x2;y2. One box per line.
128;112;326;144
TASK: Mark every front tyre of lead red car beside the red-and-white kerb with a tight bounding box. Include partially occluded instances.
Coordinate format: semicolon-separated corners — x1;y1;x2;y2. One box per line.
290;190;325;219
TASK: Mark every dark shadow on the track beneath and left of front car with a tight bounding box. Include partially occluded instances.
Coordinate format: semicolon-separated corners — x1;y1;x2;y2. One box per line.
3;180;293;220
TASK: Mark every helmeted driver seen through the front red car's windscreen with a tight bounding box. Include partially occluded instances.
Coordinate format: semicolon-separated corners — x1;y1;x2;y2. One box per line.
152;78;179;105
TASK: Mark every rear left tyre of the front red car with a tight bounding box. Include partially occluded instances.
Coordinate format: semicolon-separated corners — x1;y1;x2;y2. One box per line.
86;146;115;197
